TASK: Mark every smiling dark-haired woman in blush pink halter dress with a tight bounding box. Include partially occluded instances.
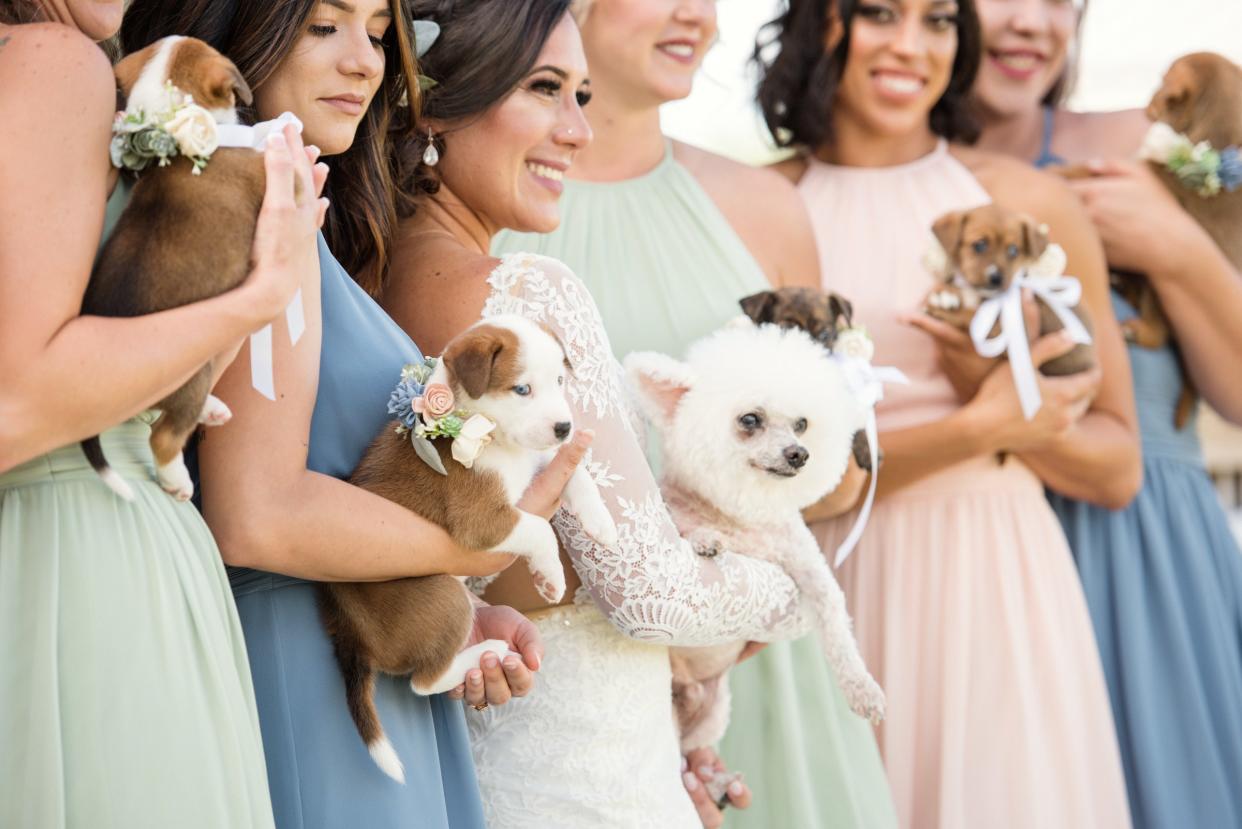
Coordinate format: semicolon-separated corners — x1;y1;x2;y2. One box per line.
759;0;1139;829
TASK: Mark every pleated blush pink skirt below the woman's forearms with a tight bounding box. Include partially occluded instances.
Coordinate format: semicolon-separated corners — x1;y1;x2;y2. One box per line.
815;456;1130;829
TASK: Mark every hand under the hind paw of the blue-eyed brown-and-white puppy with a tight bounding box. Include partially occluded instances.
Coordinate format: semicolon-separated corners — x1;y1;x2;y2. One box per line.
448;605;544;706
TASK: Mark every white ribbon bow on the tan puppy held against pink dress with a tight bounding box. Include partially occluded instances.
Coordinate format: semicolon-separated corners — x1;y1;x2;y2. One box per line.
970;271;1092;420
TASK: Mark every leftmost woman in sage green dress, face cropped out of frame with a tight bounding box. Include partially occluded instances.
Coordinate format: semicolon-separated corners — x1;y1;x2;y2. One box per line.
0;0;322;829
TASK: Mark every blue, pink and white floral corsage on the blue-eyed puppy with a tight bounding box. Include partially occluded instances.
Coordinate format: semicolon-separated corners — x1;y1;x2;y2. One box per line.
389;357;496;475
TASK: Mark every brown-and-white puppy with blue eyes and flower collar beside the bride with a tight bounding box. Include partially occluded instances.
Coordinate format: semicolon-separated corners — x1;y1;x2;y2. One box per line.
319;316;617;782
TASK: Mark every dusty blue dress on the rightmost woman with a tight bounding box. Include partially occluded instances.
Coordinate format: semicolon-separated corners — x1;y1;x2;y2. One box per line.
1040;118;1242;829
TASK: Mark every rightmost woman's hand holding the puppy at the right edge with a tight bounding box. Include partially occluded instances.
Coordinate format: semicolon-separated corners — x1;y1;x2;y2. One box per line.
1069;160;1210;275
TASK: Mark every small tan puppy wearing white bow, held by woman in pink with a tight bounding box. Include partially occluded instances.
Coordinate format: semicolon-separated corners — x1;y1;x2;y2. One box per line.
924;204;1095;407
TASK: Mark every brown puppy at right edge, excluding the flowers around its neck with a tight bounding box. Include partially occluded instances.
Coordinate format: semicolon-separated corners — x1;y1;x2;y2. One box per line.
1052;52;1242;429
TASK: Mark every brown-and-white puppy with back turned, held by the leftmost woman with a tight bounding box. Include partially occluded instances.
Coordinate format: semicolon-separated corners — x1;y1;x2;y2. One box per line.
82;36;265;501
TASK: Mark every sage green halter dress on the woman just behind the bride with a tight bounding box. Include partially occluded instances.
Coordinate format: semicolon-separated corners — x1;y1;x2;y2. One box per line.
492;145;897;829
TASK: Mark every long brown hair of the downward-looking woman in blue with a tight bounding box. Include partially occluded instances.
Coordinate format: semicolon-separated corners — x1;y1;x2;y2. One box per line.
121;0;420;295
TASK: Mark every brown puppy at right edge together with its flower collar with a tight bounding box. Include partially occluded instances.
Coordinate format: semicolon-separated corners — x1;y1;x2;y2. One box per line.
1052;52;1242;429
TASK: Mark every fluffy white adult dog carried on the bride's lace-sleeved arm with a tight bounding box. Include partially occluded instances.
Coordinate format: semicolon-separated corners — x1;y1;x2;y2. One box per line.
626;322;884;765
